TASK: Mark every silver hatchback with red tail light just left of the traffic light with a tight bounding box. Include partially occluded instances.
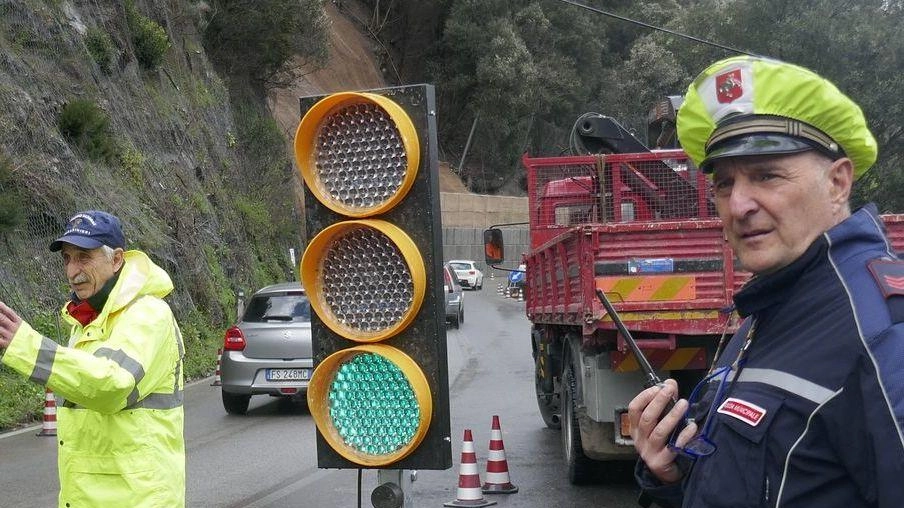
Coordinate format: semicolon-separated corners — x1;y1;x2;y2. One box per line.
220;282;314;414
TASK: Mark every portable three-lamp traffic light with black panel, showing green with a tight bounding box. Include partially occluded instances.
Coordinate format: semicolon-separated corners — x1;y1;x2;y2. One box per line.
295;85;452;469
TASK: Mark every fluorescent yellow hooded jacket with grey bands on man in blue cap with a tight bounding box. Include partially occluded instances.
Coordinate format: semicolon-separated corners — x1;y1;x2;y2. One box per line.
2;250;185;508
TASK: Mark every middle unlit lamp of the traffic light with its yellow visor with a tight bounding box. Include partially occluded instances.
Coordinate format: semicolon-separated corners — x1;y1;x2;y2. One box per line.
300;219;427;342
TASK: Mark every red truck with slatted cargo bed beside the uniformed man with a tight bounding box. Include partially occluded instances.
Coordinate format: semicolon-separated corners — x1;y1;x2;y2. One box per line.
484;129;904;483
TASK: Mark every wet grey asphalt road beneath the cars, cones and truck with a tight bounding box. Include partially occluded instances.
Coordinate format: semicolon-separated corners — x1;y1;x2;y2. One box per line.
0;277;636;508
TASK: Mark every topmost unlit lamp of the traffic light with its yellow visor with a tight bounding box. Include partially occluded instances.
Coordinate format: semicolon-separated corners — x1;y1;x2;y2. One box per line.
295;92;420;218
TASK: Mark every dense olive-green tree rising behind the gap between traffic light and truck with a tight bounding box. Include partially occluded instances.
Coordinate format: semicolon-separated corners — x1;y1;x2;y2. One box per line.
430;0;605;191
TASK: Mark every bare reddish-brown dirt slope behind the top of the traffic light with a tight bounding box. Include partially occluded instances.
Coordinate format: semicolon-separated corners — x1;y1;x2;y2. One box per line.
269;0;469;193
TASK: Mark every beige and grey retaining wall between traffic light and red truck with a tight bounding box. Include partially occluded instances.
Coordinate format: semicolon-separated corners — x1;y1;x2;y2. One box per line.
440;192;530;278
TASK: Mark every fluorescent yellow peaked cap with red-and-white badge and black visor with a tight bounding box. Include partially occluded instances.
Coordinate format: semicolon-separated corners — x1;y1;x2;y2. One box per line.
677;56;878;179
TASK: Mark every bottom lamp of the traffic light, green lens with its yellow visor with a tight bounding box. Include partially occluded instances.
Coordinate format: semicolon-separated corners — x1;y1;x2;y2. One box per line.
308;344;433;466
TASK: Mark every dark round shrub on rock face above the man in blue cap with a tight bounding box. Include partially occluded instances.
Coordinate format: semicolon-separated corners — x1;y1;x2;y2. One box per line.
58;99;119;163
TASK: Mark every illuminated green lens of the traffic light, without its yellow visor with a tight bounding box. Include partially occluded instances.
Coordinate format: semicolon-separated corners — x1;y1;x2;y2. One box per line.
329;353;420;455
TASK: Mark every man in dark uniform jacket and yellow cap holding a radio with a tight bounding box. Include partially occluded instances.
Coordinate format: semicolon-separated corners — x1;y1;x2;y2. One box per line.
629;56;904;508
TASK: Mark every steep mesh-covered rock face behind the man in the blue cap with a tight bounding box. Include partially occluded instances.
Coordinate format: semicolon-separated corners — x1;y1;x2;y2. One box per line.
0;0;290;362
